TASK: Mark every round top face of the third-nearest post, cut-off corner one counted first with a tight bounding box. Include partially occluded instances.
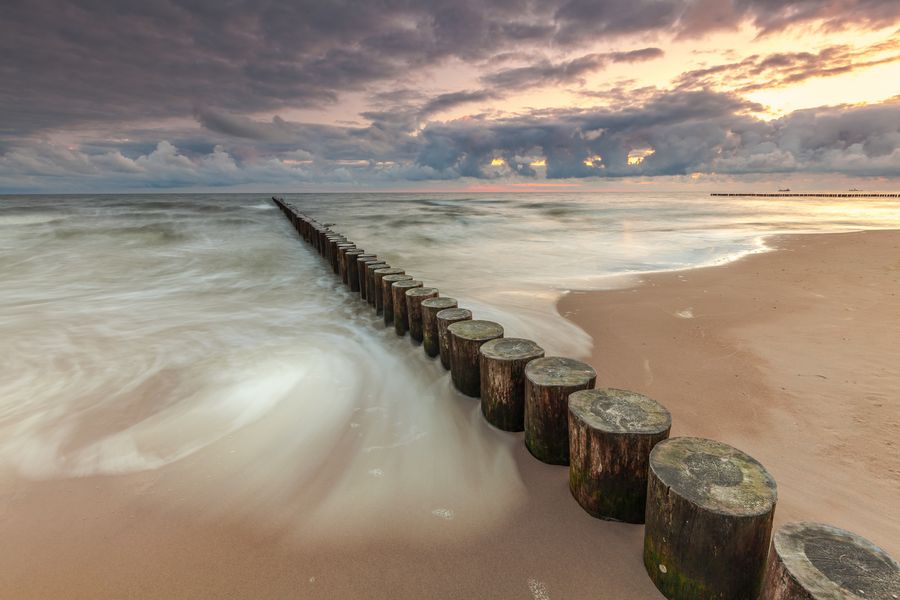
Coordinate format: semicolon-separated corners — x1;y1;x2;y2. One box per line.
569;388;672;435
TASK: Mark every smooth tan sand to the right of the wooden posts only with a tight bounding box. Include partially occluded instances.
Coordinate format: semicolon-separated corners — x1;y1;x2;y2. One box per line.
557;230;900;555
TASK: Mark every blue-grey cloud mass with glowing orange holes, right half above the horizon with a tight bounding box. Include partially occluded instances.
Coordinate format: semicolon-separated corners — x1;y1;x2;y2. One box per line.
417;91;900;179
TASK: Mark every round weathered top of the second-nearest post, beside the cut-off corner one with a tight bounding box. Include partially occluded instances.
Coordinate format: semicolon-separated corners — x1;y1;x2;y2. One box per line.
650;437;777;517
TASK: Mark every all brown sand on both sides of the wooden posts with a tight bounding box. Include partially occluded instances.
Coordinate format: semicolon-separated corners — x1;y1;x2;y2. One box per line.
0;227;900;600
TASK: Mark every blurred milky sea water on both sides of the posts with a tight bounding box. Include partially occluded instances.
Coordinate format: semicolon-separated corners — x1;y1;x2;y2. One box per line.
0;194;900;537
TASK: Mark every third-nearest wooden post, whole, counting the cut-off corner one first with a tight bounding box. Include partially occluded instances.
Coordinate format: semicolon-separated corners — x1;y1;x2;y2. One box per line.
569;389;672;523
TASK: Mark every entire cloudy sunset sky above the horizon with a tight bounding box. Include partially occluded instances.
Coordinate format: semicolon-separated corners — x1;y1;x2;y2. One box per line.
0;0;900;193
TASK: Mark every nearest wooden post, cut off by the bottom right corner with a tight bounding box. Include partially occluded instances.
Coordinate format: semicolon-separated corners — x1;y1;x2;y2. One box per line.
760;523;900;600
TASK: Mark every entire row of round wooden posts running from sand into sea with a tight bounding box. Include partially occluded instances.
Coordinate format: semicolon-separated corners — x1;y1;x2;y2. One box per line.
273;198;900;600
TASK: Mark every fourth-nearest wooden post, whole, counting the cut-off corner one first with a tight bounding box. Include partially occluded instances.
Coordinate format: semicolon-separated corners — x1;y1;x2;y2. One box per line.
525;356;597;465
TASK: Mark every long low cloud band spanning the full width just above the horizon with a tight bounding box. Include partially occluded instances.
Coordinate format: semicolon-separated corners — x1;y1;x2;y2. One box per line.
7;91;900;191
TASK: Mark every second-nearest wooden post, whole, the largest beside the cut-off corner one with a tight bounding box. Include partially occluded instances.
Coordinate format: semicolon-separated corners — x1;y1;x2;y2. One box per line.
644;437;776;600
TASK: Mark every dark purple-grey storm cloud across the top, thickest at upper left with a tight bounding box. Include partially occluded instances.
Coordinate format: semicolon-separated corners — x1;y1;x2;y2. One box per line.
0;0;900;140
